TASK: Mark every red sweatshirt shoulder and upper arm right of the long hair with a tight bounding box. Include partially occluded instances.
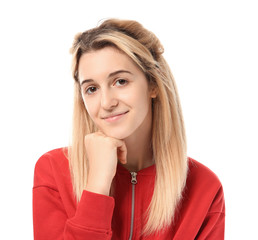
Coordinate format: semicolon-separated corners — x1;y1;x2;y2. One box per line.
176;158;225;239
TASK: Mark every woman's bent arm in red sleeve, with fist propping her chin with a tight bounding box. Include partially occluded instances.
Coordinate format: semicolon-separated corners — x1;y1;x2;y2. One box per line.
33;133;126;240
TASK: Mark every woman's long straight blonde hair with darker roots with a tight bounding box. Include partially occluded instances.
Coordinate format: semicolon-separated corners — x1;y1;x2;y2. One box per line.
69;19;188;235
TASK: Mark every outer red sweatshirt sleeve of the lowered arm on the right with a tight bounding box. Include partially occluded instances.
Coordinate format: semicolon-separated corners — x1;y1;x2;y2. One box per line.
196;187;225;240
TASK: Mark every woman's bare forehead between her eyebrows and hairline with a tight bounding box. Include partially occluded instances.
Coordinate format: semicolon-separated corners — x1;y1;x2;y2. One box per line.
78;47;141;82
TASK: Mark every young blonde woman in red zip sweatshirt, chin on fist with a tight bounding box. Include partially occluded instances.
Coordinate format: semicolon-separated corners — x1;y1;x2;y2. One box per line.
33;19;225;240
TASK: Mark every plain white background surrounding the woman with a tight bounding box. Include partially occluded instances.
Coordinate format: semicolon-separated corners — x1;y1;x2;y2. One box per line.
0;0;258;240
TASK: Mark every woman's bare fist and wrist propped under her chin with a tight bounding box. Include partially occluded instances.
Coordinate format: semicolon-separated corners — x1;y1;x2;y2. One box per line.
85;132;127;195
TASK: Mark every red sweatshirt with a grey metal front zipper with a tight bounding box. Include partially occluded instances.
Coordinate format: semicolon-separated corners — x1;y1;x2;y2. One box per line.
33;149;225;240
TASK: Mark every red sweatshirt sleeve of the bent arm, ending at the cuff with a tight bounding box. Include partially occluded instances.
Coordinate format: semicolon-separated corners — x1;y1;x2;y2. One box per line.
33;153;114;240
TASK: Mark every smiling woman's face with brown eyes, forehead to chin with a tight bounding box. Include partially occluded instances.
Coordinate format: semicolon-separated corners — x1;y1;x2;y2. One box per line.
78;47;155;139
